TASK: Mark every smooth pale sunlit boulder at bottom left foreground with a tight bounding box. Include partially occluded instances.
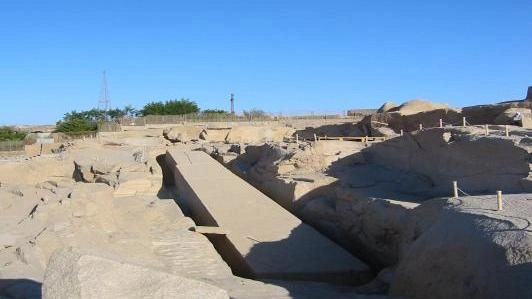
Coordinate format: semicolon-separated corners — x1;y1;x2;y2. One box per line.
42;247;229;299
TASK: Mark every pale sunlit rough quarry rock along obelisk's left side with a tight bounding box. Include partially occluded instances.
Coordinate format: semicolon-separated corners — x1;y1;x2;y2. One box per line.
0;129;388;298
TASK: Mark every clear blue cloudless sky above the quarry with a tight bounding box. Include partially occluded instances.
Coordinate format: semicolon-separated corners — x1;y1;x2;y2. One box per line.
0;0;532;124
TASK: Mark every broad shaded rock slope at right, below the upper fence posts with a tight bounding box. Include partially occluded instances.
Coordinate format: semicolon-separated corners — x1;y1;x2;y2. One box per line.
362;129;532;197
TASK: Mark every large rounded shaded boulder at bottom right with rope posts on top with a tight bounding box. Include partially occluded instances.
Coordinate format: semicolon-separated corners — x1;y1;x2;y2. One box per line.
391;196;532;299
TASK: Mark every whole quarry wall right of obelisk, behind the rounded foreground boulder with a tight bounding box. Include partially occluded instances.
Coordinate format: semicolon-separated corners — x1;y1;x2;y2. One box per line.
229;129;532;278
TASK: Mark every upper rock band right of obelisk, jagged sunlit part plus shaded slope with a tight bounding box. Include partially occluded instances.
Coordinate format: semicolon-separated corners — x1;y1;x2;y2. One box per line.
232;129;532;209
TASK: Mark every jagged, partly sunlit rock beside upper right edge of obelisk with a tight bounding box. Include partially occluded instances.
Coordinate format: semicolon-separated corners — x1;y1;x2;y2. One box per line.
227;141;363;211
